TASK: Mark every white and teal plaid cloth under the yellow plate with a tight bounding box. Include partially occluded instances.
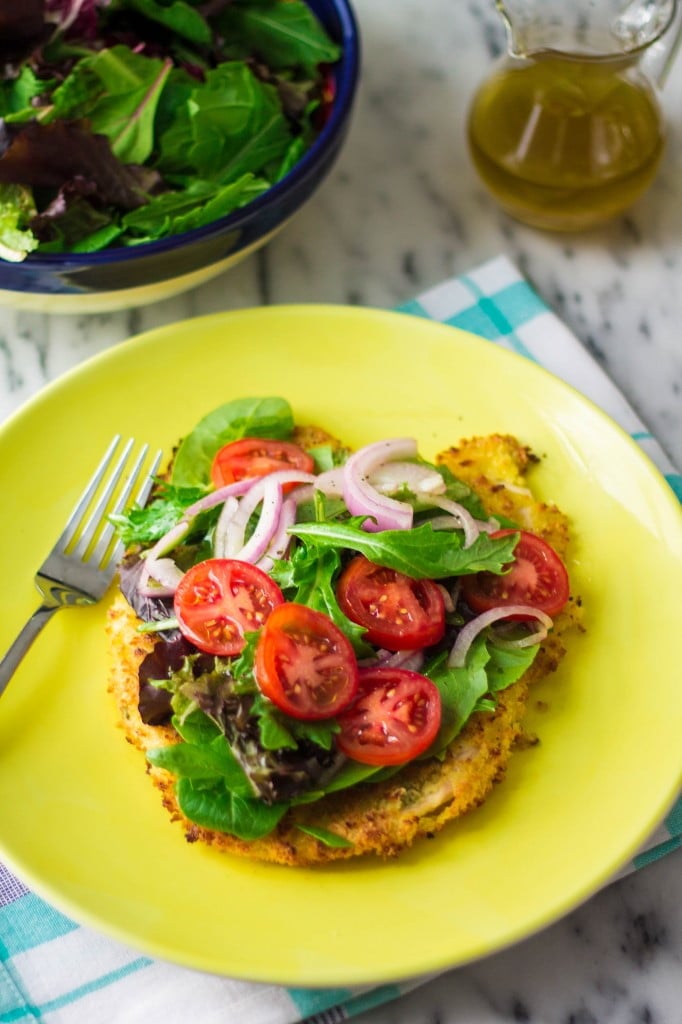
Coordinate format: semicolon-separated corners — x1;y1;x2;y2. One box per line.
0;257;682;1024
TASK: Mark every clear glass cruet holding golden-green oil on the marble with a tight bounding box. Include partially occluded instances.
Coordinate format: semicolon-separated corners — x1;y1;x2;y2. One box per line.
467;0;682;231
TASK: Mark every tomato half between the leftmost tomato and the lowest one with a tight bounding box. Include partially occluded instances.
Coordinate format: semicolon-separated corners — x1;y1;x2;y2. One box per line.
255;603;358;719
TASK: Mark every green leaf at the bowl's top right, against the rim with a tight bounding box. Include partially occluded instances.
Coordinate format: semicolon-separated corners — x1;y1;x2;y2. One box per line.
220;0;340;73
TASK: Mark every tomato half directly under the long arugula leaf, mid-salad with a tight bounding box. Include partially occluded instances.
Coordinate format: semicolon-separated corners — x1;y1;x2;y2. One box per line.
336;555;445;650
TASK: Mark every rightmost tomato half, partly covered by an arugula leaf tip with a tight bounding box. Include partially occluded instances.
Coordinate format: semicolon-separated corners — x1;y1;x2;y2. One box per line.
462;529;569;617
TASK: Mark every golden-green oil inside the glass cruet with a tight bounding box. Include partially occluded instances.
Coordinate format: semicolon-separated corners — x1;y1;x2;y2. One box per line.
469;54;664;230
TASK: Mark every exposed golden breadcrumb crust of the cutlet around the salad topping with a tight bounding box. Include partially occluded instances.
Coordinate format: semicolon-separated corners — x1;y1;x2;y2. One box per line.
106;428;580;865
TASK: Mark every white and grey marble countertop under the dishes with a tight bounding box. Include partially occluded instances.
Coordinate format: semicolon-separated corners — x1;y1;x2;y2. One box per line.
0;0;682;1024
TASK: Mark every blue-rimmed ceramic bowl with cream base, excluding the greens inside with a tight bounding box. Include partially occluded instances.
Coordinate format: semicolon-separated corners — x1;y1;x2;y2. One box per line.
0;0;359;313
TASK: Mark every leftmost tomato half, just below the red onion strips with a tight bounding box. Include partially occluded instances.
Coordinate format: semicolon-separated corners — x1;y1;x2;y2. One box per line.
173;558;284;657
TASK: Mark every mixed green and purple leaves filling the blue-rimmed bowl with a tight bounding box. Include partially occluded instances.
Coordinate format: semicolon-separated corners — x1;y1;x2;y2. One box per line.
0;0;340;261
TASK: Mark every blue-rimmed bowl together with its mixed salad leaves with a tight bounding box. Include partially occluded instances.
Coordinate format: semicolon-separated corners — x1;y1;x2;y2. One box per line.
0;0;359;312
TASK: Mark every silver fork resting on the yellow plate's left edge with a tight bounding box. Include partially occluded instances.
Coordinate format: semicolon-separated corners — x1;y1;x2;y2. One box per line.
0;434;162;696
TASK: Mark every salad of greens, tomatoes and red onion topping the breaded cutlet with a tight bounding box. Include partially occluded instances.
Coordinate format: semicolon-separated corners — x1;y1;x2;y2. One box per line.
116;397;568;845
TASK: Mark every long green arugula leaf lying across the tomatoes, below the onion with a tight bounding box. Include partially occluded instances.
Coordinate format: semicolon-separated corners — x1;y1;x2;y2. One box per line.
289;517;518;580
